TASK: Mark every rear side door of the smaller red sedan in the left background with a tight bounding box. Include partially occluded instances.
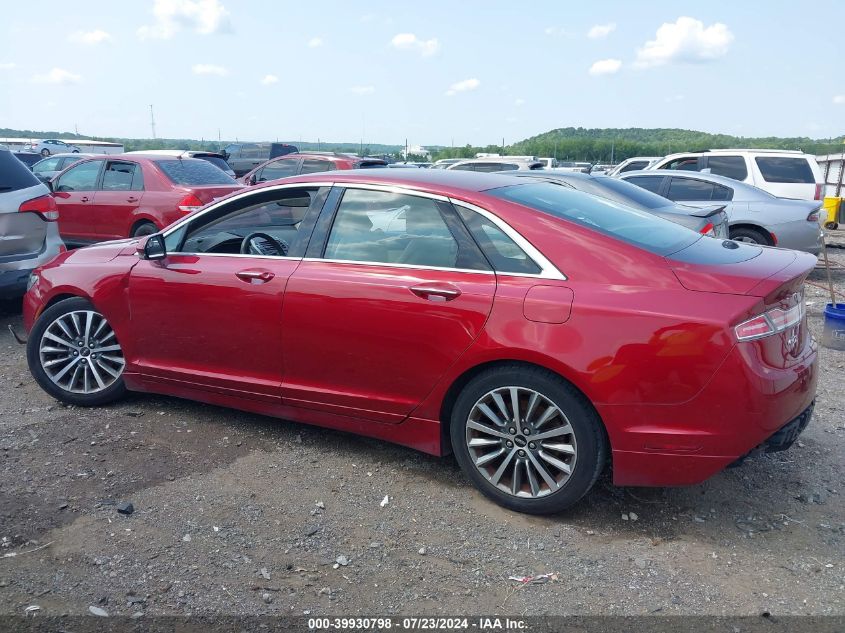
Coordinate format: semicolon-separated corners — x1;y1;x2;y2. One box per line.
94;160;144;239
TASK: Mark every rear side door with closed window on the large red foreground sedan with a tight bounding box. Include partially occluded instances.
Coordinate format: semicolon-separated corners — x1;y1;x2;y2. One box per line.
282;185;496;423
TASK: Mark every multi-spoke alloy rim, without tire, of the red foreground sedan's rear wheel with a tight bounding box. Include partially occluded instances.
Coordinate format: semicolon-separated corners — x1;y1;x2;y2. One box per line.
466;386;578;498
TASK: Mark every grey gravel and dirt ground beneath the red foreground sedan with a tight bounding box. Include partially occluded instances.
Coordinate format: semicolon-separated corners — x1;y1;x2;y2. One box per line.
0;235;845;615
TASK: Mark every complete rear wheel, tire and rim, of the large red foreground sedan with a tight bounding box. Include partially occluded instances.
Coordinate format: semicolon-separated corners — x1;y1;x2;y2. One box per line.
450;366;607;514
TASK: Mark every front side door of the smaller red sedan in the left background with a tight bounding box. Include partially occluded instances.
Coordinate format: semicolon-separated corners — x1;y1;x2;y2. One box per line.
51;159;105;245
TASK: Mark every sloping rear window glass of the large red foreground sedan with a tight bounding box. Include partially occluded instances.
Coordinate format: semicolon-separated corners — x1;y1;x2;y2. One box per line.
488;182;701;256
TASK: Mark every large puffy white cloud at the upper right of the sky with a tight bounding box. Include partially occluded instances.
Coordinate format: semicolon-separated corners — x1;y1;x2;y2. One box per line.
634;17;734;68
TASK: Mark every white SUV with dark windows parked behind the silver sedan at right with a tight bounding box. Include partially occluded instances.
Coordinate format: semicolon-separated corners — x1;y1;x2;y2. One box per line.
647;149;824;200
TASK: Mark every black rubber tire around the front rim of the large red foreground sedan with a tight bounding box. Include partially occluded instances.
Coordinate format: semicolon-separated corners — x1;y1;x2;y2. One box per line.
26;297;126;407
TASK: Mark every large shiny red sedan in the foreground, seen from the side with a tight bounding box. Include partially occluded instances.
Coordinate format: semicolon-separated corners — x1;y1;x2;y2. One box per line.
24;170;817;513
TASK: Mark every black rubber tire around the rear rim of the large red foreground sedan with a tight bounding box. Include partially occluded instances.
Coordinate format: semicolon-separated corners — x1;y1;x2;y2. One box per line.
450;365;608;514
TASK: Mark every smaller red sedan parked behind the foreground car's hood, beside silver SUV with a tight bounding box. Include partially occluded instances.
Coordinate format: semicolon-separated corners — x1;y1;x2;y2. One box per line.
50;154;242;246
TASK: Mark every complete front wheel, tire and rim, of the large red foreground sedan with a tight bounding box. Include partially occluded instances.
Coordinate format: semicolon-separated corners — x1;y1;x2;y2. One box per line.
26;297;126;407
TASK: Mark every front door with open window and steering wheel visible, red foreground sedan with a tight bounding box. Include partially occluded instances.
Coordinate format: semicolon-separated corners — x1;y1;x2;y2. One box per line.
124;185;328;403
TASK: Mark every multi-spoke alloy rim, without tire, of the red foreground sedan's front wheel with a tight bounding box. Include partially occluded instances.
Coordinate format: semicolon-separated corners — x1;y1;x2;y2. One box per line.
38;310;126;394
